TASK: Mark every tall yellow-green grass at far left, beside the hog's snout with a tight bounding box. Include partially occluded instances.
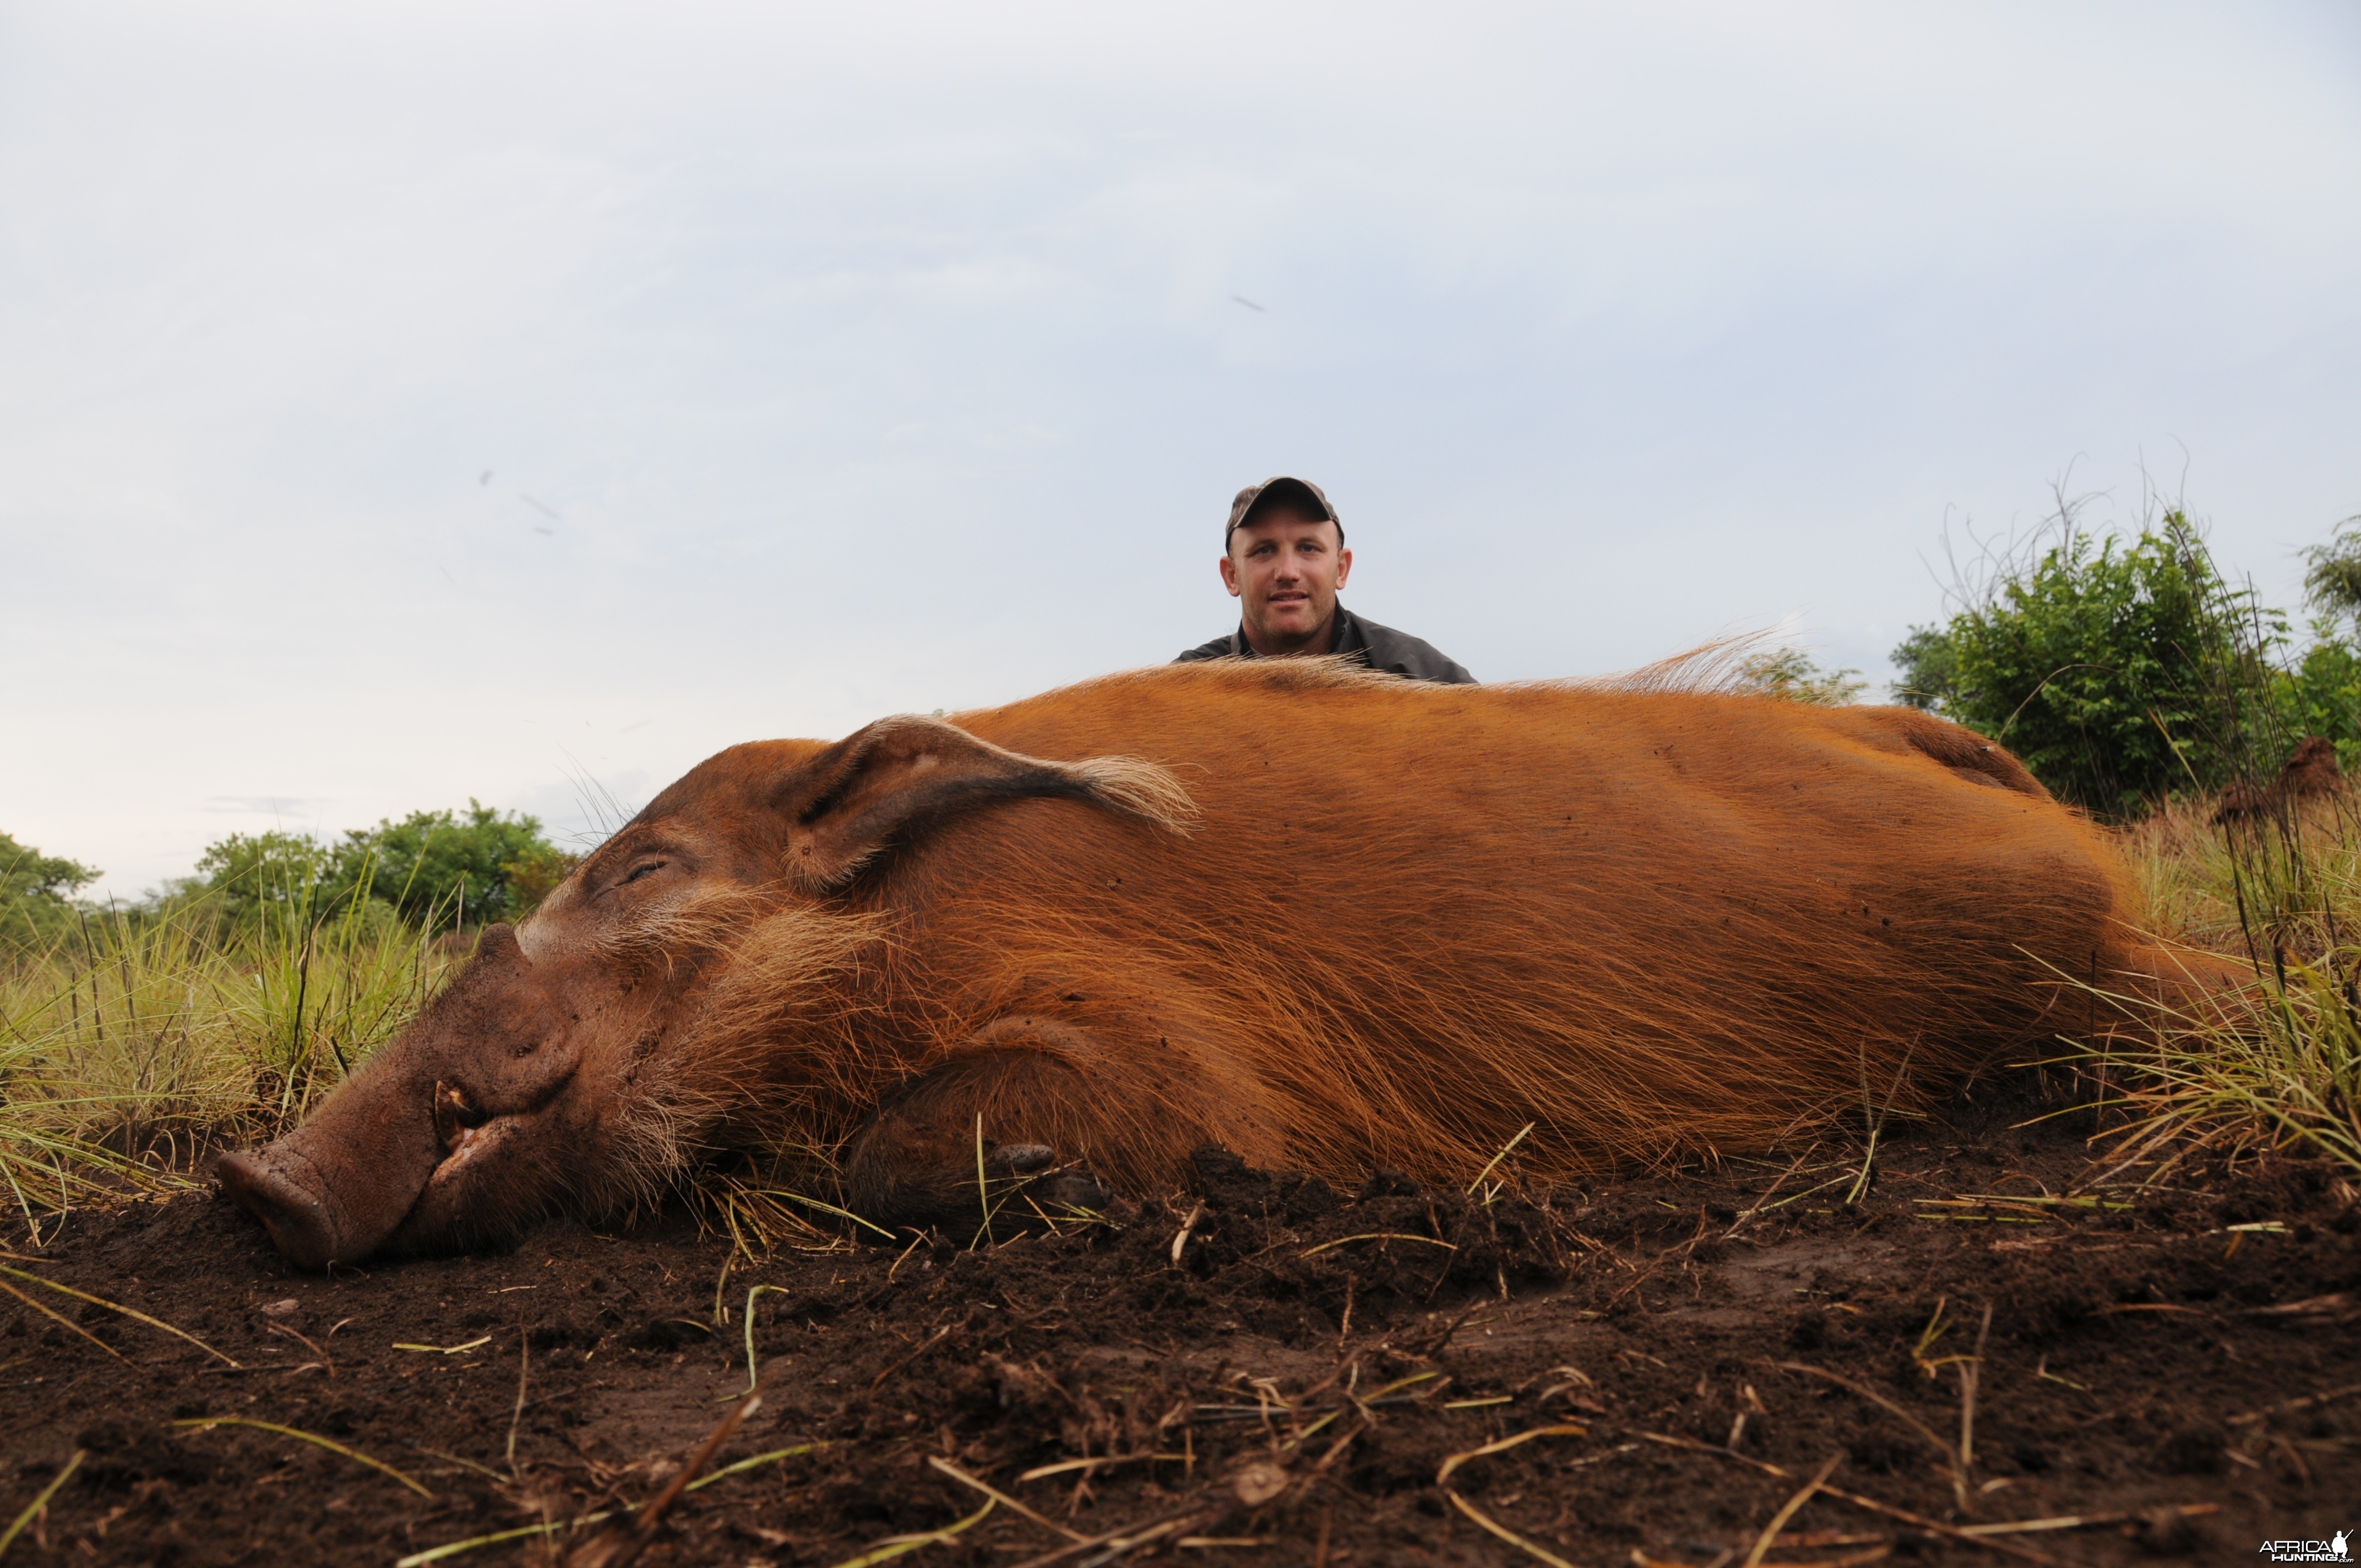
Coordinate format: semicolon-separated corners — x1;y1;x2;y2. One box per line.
0;897;463;1240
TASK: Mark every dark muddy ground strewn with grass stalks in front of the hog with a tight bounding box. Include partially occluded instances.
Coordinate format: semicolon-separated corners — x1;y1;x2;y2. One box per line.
0;1086;2361;1568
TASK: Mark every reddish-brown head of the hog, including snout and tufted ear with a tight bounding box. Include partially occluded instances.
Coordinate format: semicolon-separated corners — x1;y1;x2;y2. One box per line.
220;718;1192;1268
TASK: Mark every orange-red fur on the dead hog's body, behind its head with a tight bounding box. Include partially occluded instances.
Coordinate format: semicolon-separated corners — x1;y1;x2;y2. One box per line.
649;661;2191;1185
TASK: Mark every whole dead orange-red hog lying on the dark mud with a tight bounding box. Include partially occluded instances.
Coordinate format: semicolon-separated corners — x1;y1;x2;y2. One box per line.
220;661;2210;1268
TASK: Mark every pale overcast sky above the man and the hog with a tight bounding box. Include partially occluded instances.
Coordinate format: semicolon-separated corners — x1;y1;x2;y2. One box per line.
0;0;2361;895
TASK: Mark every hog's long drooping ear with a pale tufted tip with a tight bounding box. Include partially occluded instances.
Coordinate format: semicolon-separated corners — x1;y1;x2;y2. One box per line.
772;716;1197;892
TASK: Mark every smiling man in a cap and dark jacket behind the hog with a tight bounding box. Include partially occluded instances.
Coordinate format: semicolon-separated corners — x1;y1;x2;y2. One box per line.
1173;477;1476;685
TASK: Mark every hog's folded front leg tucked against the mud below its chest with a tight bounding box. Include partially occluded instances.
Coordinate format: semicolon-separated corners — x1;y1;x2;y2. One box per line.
845;1018;1280;1240
